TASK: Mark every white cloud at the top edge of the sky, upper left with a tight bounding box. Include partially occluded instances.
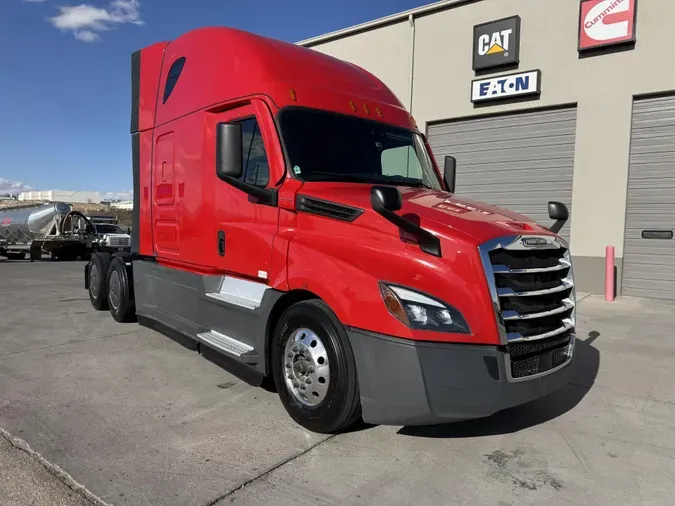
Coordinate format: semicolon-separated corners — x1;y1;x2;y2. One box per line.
48;0;144;42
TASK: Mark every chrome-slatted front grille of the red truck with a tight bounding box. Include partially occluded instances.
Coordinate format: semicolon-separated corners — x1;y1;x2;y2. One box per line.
480;235;576;381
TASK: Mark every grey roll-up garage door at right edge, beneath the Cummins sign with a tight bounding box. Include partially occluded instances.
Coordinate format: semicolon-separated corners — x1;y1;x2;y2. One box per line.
622;96;675;299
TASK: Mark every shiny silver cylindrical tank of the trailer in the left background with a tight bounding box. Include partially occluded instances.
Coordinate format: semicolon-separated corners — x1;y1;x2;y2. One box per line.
0;202;72;244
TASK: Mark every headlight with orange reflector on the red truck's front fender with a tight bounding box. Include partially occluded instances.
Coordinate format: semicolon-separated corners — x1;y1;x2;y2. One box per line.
380;283;471;334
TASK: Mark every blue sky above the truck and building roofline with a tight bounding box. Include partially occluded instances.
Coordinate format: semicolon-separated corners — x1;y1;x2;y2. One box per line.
0;0;430;201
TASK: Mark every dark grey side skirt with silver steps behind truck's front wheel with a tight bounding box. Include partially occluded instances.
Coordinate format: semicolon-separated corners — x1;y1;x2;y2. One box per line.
132;259;283;384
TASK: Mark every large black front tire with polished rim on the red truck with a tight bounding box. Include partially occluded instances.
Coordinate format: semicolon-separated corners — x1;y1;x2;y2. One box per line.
272;300;361;434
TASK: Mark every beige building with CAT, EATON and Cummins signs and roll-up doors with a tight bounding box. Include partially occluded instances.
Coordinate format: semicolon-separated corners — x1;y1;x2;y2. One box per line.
299;0;675;299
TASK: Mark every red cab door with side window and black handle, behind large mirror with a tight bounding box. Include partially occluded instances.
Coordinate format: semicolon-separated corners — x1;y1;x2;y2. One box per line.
213;104;279;281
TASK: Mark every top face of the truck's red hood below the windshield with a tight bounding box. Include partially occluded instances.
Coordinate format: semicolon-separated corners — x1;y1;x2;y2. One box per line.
299;182;555;243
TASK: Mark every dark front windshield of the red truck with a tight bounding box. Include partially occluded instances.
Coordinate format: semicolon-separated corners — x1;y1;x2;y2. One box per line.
279;108;442;190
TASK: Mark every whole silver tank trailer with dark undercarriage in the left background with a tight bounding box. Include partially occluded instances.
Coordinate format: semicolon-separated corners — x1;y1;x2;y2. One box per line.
0;202;93;262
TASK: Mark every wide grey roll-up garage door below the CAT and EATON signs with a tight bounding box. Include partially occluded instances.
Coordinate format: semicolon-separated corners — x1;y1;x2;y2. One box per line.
427;107;577;240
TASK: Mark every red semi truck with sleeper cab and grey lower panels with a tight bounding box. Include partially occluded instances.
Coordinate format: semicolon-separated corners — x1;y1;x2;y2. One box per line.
85;27;575;433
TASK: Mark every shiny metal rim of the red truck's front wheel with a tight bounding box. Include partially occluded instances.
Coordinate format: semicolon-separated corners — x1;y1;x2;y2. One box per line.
282;328;330;406
